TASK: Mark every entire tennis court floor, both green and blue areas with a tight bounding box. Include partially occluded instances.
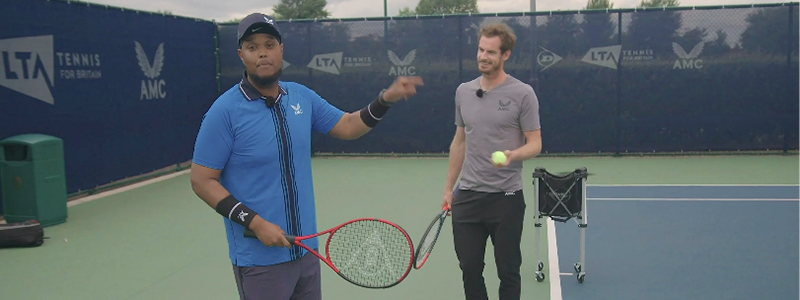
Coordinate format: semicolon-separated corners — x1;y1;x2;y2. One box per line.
0;154;799;300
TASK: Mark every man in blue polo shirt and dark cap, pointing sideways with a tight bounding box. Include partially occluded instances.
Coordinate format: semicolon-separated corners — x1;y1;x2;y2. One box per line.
191;13;422;300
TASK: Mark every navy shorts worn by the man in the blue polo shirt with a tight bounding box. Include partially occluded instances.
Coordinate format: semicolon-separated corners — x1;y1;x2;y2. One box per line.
233;253;322;300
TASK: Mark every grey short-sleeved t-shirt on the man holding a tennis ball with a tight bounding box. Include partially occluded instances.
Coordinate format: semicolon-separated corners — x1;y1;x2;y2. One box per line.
455;75;541;192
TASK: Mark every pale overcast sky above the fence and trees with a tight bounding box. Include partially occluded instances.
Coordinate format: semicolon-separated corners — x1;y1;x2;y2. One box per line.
83;0;788;22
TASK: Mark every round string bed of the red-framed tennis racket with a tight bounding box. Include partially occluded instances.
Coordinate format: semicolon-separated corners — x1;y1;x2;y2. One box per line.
328;220;412;287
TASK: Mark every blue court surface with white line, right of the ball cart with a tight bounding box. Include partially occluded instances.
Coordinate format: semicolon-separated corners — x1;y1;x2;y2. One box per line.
548;185;800;300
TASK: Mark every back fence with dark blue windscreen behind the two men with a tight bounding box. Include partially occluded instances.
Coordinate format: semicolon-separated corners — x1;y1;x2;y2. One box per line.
219;3;798;155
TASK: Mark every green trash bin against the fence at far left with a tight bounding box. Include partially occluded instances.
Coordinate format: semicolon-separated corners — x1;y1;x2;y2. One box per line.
0;134;67;227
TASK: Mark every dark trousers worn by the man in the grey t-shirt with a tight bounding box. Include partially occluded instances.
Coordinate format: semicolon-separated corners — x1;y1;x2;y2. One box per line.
451;191;526;300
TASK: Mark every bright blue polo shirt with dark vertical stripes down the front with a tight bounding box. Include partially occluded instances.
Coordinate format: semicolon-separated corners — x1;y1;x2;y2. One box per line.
193;74;344;266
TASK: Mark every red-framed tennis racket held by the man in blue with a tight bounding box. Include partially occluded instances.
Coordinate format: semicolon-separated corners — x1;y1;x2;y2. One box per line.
244;218;414;288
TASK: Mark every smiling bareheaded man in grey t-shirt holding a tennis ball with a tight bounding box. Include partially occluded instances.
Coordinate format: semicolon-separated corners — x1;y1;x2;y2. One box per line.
443;23;542;300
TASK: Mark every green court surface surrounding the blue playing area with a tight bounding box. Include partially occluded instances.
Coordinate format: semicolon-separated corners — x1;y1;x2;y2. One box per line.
0;155;798;300
